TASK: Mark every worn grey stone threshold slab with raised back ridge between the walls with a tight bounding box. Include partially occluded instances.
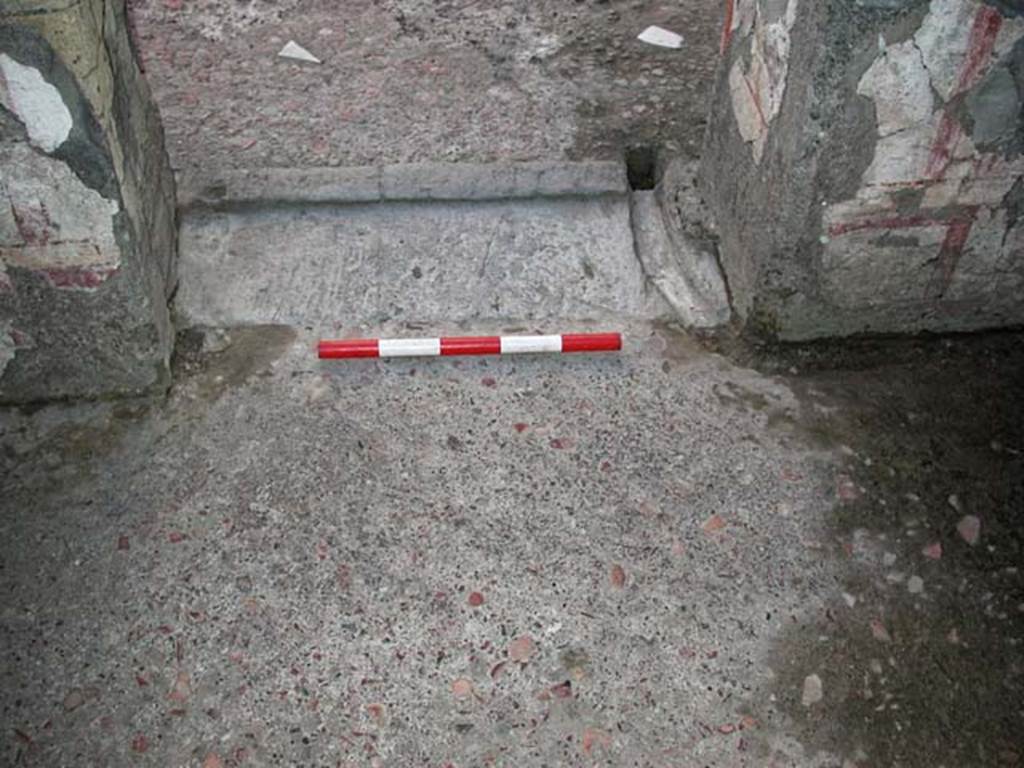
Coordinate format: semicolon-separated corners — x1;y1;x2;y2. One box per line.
176;163;670;328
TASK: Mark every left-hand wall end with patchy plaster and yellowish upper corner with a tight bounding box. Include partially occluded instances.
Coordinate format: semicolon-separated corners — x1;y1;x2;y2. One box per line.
0;0;176;401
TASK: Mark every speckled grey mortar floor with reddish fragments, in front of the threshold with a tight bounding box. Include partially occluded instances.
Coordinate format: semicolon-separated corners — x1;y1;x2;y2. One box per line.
0;323;1024;768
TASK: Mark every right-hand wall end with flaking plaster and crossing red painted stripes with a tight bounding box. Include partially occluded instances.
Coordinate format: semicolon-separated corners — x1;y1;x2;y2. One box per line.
703;0;1024;339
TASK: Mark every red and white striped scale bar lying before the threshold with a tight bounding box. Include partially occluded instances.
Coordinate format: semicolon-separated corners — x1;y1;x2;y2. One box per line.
317;333;623;359
